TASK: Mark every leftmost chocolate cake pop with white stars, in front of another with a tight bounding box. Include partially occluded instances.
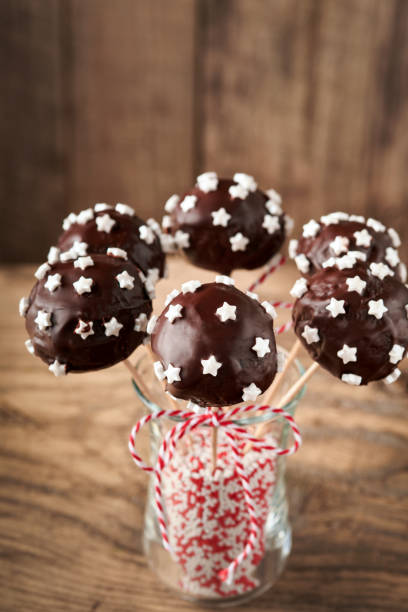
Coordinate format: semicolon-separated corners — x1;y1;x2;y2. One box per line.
20;252;152;376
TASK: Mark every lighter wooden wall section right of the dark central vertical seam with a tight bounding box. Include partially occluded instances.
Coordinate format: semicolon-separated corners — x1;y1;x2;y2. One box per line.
201;0;408;257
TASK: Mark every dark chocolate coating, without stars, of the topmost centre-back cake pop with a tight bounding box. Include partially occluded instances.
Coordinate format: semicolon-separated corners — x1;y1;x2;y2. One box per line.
170;179;285;274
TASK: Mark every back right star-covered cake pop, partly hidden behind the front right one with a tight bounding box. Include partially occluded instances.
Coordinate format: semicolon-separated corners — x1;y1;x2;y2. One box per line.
289;212;407;283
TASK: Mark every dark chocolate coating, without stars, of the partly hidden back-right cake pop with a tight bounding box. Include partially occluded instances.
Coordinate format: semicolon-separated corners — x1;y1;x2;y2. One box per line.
296;220;405;282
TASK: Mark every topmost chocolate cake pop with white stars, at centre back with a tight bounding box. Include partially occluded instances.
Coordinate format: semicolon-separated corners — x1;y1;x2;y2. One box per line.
162;172;291;274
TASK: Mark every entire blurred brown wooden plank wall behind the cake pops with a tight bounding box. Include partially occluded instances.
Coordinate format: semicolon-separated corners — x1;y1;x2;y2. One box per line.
0;0;408;262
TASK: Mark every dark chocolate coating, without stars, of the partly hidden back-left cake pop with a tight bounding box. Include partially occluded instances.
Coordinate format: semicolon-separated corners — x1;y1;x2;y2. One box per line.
58;208;165;278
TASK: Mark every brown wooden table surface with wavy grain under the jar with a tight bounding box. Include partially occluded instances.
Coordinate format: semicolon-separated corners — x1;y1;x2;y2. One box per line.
0;259;408;612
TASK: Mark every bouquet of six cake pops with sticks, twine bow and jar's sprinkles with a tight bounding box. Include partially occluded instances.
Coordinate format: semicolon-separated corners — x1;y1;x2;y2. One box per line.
20;172;408;598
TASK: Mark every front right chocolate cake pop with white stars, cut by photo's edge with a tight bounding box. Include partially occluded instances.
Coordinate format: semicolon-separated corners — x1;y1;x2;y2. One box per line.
291;264;408;385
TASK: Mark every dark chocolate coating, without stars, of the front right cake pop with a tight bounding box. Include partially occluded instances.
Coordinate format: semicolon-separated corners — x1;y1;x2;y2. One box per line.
292;265;408;385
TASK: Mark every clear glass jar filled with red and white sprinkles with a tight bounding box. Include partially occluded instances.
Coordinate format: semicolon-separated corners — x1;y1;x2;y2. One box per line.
133;348;305;607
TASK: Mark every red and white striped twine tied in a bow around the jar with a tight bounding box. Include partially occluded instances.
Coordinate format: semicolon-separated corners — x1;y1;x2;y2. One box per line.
129;405;302;583
